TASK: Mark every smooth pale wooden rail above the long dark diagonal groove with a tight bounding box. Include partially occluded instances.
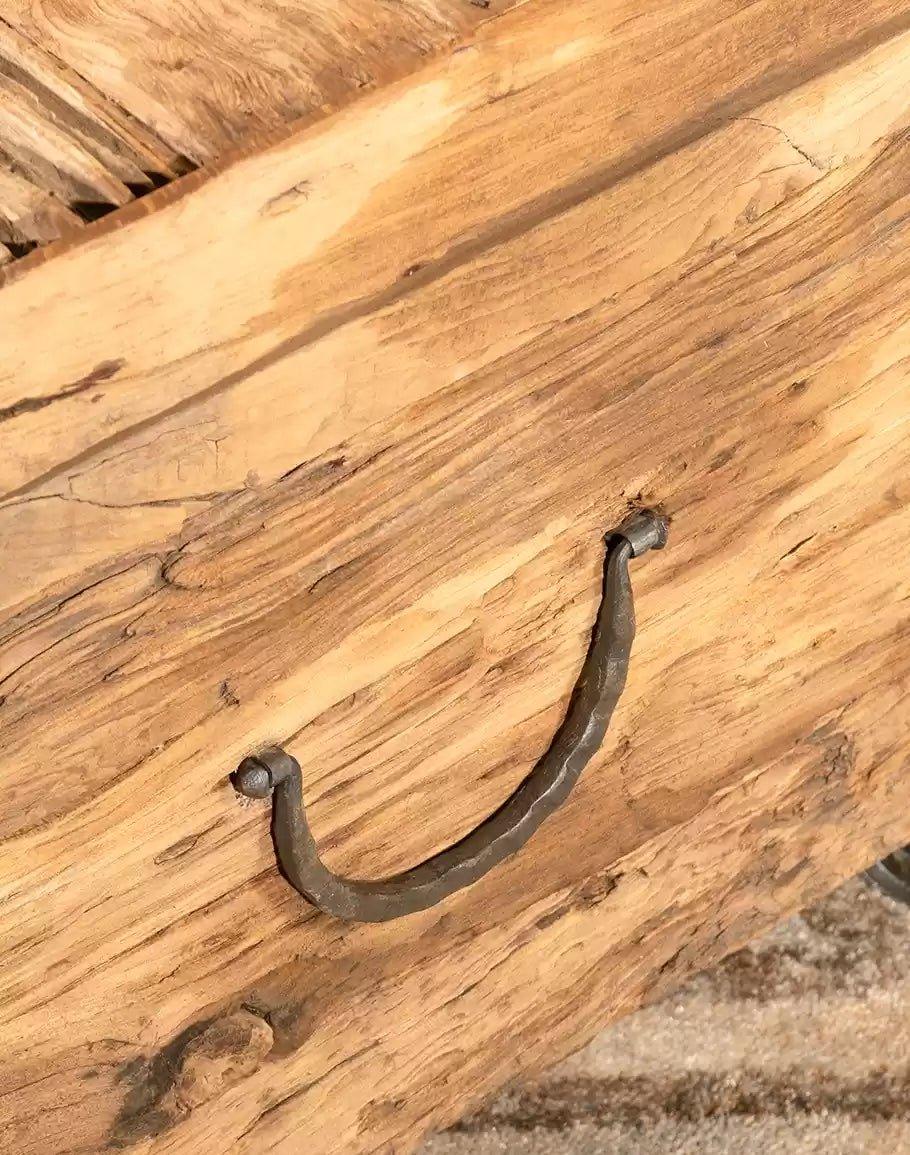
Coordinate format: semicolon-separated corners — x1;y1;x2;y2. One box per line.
0;0;910;493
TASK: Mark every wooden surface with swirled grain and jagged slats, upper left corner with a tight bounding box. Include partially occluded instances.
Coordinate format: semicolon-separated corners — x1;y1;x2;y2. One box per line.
0;0;514;252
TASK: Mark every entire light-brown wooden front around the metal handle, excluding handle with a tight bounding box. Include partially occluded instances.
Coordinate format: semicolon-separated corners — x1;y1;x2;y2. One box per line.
0;0;910;1155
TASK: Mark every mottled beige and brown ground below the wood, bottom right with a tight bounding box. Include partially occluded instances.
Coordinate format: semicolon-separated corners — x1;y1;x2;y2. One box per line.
422;879;910;1155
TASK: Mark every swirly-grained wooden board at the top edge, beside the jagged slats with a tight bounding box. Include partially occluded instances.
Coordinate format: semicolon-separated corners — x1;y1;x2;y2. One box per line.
2;0;514;173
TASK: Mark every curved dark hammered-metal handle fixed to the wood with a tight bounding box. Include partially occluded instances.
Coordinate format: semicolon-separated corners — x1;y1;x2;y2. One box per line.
233;511;667;923
